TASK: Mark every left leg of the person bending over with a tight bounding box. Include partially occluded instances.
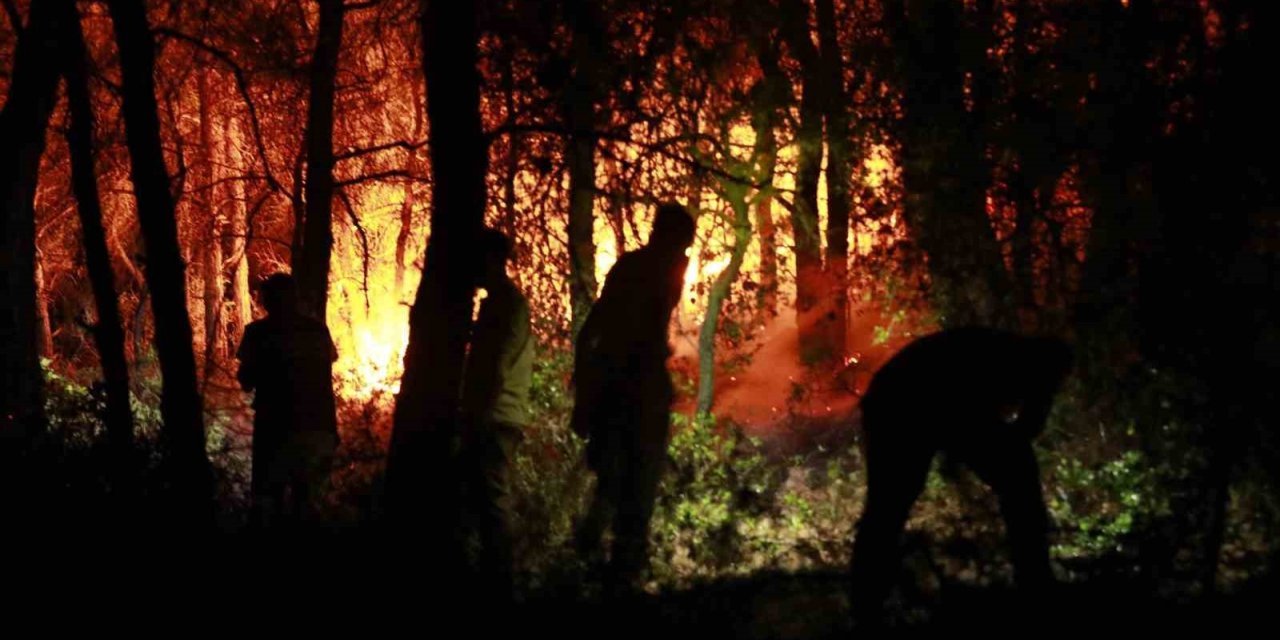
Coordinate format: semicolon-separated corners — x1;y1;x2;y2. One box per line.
850;424;934;626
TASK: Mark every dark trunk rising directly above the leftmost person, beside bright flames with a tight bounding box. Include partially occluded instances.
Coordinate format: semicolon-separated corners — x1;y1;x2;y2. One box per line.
293;0;343;320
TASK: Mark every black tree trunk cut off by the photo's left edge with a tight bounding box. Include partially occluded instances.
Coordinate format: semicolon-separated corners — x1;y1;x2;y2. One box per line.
0;1;60;463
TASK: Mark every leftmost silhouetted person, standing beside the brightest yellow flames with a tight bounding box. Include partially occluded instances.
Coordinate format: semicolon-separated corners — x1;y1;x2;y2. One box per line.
237;274;338;527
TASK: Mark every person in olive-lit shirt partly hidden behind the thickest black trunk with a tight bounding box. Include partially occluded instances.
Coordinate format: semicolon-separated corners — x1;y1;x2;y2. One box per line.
460;229;534;600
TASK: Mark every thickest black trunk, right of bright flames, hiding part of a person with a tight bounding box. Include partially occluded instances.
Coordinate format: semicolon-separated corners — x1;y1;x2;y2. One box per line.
387;0;488;532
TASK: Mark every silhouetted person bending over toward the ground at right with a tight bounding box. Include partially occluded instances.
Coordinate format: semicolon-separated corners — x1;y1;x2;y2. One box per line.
852;328;1071;626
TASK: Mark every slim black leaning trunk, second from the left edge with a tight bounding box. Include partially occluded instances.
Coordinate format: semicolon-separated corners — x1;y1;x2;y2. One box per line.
63;3;133;481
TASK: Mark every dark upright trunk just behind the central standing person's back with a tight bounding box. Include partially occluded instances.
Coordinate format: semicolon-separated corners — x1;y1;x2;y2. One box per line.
564;0;602;339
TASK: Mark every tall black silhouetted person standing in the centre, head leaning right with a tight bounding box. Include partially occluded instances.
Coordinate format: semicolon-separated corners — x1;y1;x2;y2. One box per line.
572;205;694;590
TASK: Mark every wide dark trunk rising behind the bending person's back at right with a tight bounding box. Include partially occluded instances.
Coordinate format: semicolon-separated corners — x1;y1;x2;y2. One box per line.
886;0;1011;326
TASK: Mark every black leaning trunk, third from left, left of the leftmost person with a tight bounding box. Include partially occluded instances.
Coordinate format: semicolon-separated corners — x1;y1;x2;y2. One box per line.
109;0;212;526
